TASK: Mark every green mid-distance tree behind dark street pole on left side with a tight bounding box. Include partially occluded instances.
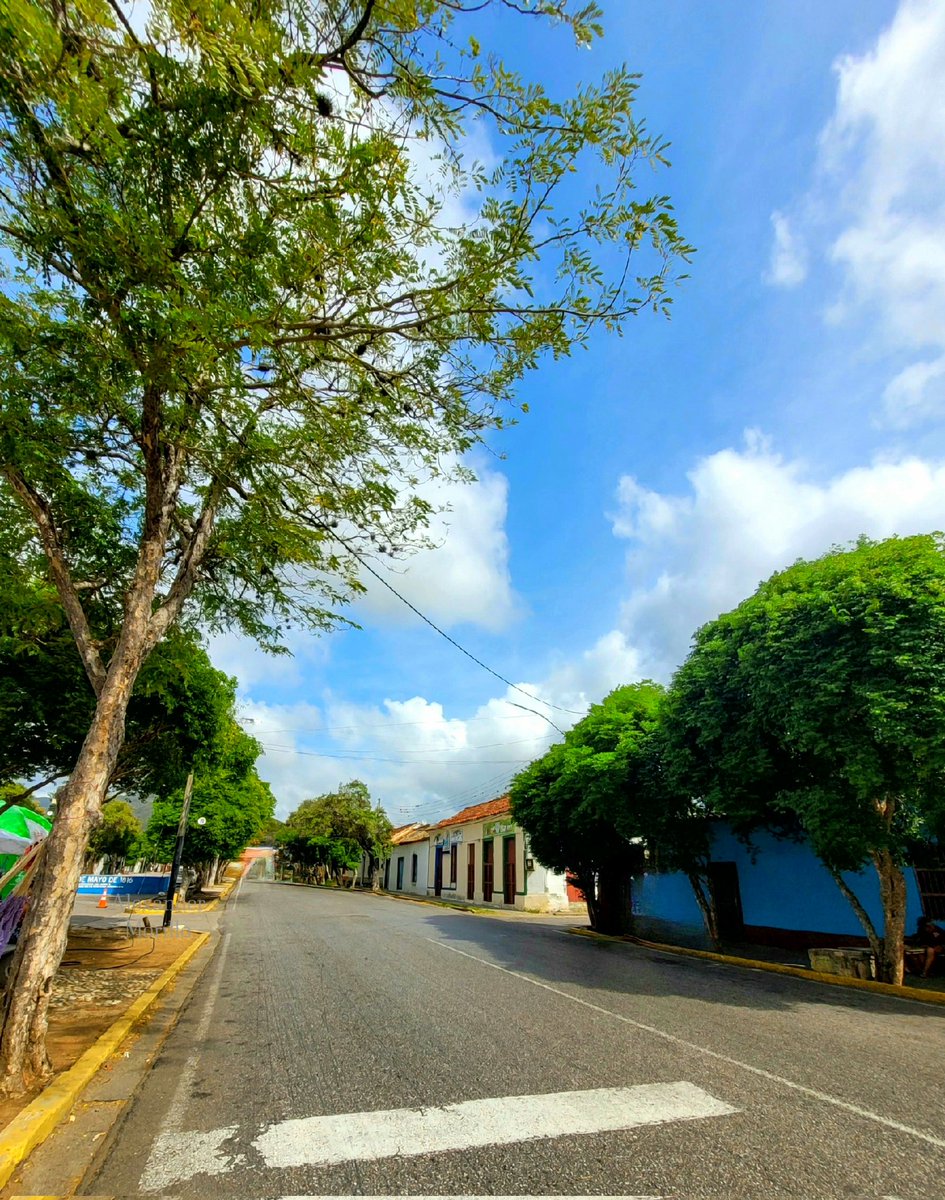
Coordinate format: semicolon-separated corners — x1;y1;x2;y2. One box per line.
144;720;276;886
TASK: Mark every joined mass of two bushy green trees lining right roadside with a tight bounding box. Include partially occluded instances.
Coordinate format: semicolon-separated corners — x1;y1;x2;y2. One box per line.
511;534;945;983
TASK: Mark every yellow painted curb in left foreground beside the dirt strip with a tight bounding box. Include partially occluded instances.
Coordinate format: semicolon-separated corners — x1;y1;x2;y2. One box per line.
0;934;210;1187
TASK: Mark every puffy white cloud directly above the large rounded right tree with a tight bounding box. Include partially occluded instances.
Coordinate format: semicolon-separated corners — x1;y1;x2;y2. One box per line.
613;433;945;678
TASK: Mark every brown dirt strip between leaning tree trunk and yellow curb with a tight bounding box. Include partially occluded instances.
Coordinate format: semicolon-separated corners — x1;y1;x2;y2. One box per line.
0;932;200;1127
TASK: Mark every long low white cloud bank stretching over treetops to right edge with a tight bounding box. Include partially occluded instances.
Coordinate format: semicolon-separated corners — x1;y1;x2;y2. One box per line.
245;433;945;823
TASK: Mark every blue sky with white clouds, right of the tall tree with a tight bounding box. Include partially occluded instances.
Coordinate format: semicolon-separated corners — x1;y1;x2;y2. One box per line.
213;0;945;823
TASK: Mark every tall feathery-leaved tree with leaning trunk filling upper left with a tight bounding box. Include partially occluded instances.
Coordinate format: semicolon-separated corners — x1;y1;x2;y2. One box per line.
0;0;688;1092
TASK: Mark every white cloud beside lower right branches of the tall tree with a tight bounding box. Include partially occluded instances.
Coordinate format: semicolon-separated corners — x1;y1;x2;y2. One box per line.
355;456;518;630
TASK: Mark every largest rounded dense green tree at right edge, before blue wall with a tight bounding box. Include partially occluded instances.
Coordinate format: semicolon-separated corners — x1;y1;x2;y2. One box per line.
667;535;945;983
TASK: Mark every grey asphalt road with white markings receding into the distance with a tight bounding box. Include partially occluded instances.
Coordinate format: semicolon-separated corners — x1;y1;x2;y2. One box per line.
85;883;945;1200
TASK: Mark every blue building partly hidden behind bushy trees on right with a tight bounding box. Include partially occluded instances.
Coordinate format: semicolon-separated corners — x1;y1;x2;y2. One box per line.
633;823;945;948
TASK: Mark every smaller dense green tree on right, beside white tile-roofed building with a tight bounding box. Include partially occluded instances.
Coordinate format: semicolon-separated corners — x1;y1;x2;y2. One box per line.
510;680;663;934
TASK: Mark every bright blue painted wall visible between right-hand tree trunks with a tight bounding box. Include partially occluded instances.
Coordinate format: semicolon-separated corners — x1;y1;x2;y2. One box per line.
633;827;922;937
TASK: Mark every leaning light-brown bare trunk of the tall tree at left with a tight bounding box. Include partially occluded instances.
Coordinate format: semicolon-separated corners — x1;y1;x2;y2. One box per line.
0;638;146;1096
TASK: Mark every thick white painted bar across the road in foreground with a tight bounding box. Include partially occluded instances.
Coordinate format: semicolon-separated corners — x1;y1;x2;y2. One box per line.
253;1082;738;1170
